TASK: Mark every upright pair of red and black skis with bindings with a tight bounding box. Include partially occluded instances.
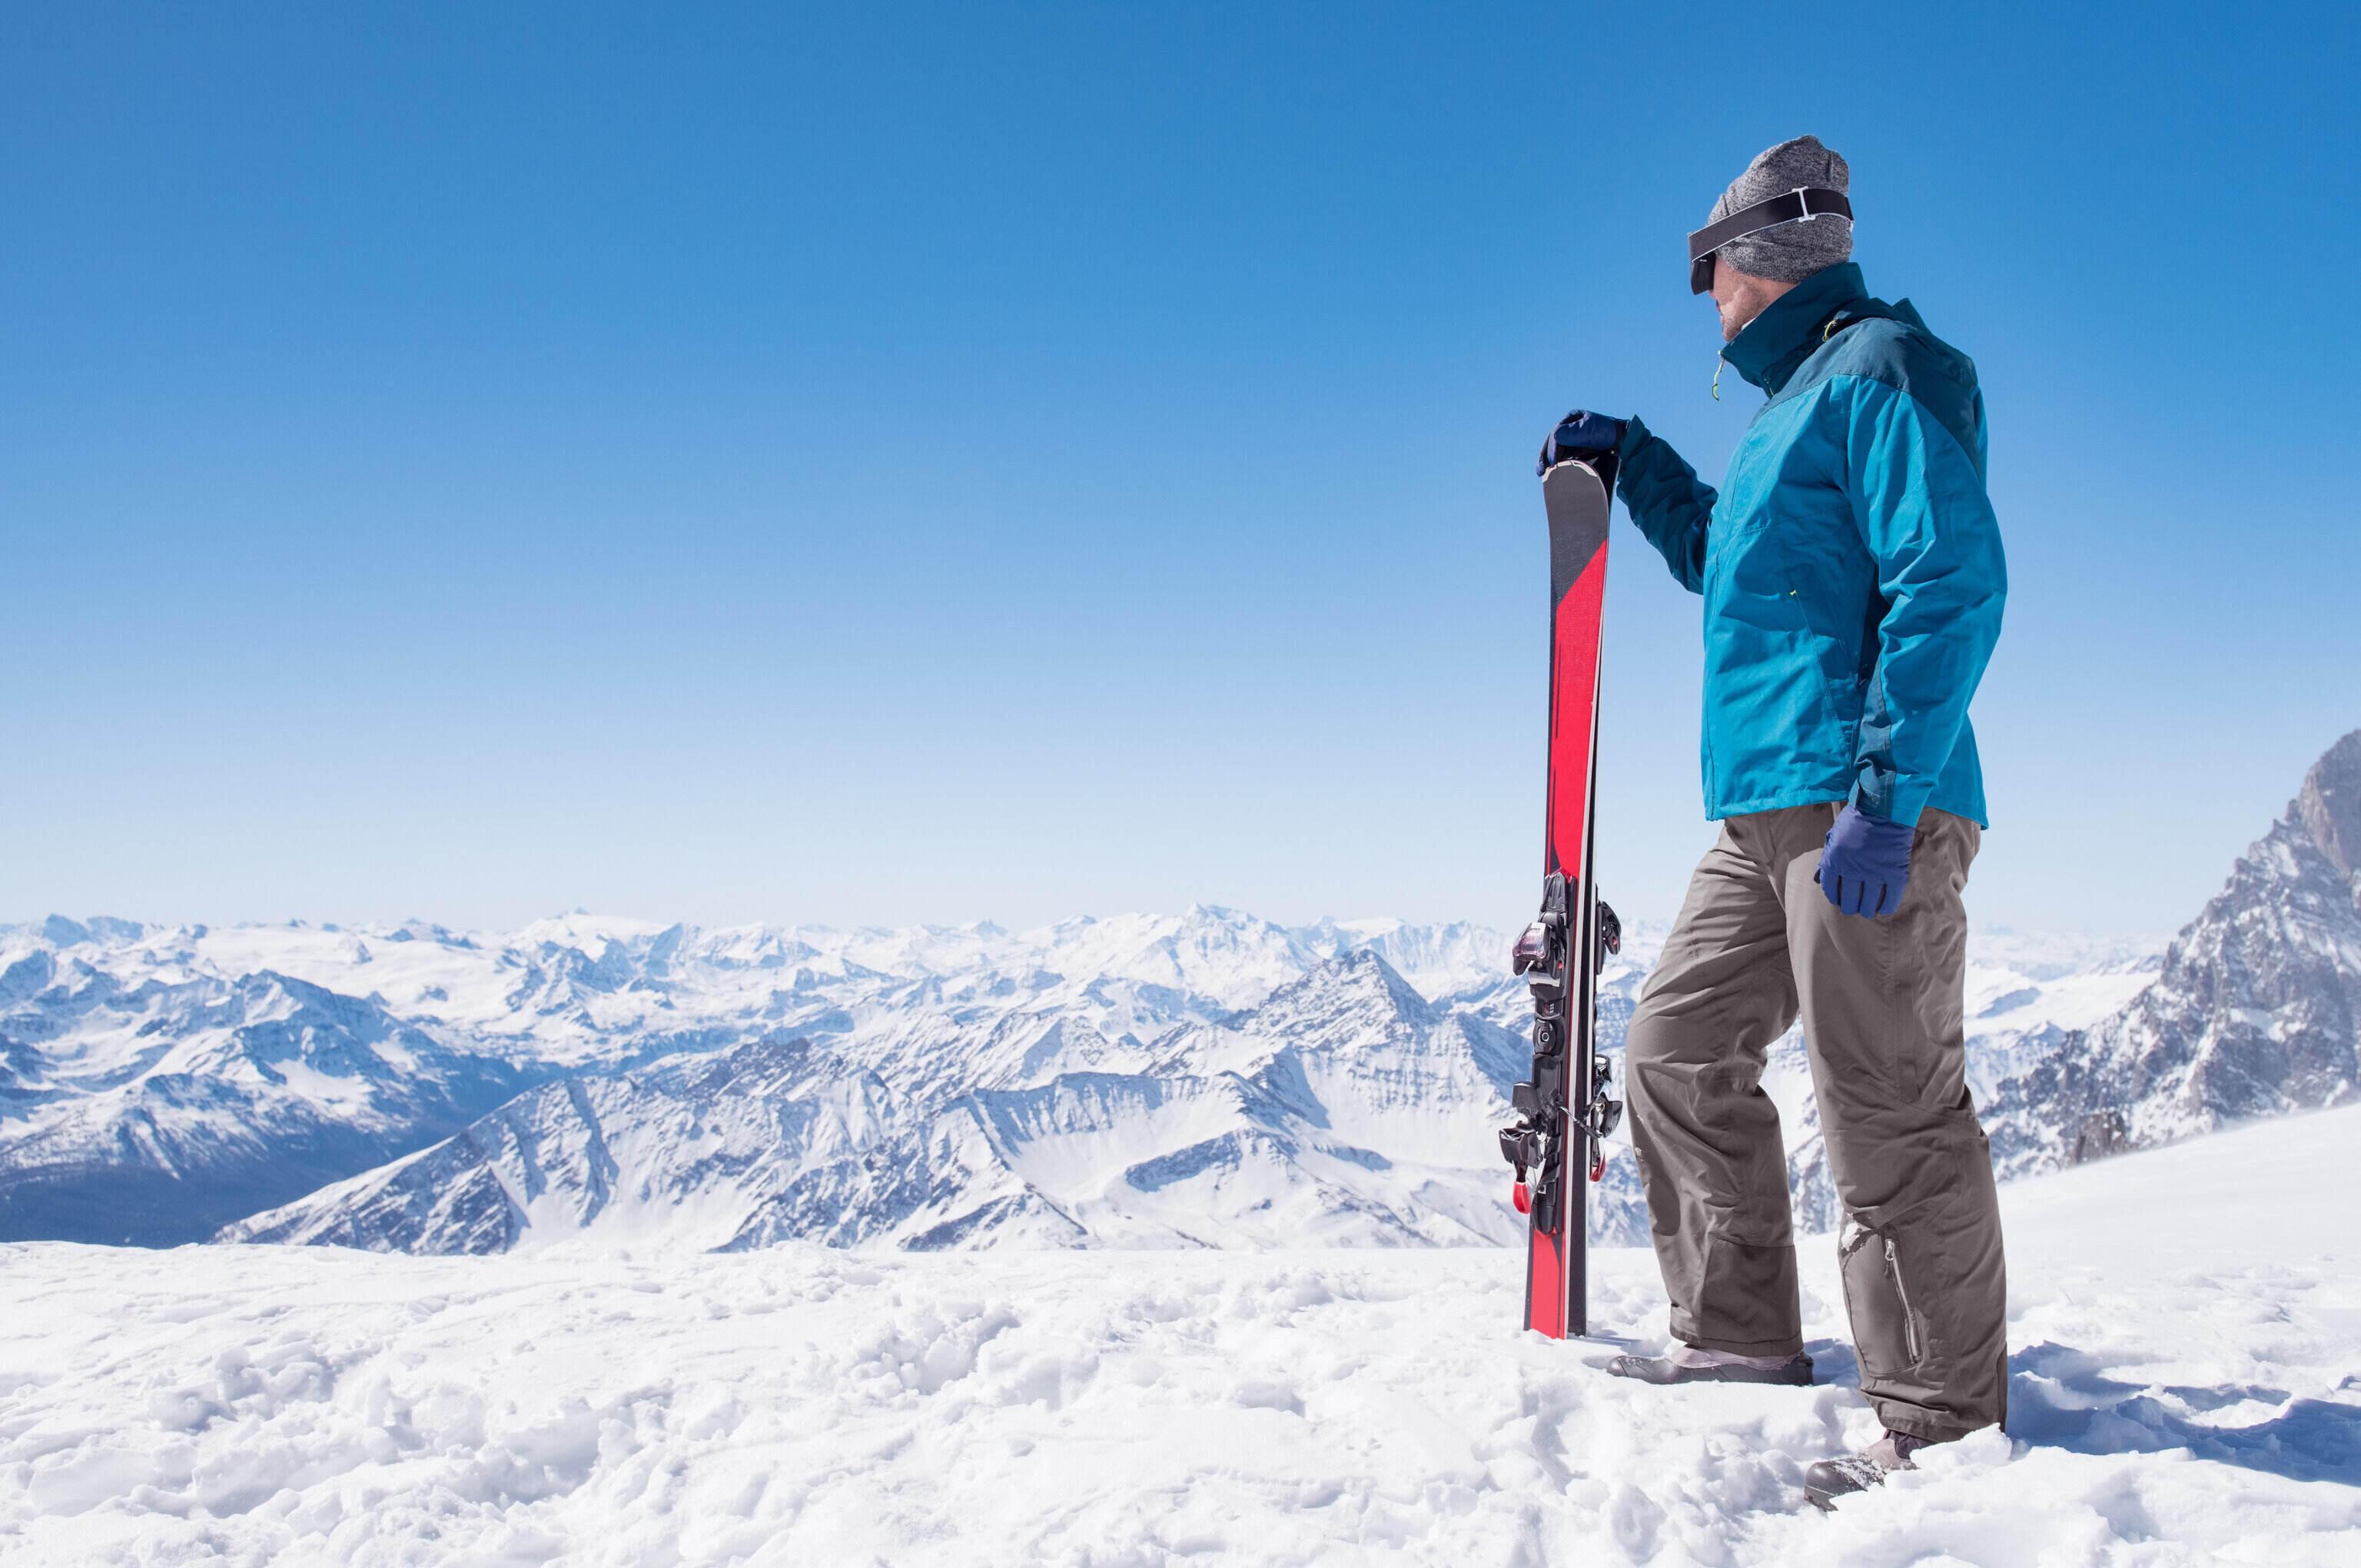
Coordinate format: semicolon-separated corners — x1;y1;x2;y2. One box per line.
1499;439;1622;1339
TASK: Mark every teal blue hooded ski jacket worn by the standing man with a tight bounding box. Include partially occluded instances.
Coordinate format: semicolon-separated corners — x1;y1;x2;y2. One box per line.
1615;262;2007;824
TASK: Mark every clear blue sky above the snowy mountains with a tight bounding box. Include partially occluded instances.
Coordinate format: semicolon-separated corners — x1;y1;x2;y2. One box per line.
0;5;2361;928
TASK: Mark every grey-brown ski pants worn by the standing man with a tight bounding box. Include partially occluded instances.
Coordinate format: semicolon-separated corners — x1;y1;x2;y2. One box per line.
1625;806;2009;1440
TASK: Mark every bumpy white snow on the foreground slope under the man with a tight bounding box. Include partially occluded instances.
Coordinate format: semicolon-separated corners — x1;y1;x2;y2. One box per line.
0;1108;2361;1568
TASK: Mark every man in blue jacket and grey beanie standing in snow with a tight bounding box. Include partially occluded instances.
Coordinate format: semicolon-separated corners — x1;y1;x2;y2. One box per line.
1556;137;2007;1507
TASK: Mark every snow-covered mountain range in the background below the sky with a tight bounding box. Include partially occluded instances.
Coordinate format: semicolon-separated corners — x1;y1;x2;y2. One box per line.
0;734;2361;1251
